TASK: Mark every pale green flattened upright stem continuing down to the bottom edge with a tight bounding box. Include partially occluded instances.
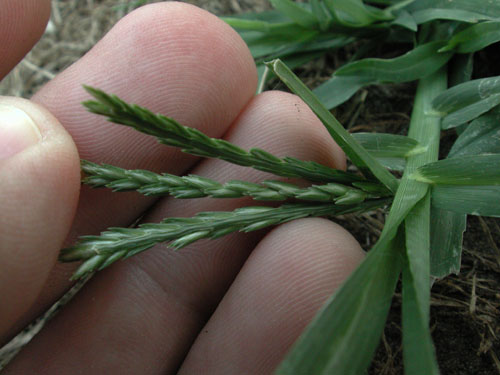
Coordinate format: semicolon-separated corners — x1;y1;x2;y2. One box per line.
379;69;447;375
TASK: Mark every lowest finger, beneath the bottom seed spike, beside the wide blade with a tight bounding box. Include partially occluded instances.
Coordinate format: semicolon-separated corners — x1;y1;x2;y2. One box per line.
179;219;364;374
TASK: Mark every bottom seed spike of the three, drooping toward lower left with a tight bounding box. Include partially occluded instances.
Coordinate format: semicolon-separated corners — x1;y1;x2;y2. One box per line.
59;198;390;279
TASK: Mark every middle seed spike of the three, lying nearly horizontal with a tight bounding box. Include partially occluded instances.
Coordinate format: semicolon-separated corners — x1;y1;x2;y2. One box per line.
81;160;391;205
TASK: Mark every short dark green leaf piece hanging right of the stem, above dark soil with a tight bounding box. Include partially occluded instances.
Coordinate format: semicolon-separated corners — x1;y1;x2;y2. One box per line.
431;205;467;279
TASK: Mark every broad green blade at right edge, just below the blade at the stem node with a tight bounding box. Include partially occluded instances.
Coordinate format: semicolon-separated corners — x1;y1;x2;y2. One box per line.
432;185;500;217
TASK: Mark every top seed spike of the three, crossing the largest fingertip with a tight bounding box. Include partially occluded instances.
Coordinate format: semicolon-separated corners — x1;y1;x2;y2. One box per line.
83;86;366;183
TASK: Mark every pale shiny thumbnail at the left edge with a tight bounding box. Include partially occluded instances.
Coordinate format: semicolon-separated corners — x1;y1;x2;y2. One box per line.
0;104;42;160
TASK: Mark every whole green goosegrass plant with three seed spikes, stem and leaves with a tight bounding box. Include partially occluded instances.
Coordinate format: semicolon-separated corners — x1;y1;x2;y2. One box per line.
60;0;500;375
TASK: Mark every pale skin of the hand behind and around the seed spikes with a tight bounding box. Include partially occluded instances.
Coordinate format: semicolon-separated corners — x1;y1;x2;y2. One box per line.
0;0;363;374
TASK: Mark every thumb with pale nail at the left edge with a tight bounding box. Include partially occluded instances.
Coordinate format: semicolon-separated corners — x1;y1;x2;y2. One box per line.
0;97;80;337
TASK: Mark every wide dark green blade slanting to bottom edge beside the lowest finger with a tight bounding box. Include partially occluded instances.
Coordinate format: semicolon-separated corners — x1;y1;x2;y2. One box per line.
276;231;404;375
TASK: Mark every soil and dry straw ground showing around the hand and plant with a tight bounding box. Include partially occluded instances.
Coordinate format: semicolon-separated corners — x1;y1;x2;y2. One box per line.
0;0;500;375
